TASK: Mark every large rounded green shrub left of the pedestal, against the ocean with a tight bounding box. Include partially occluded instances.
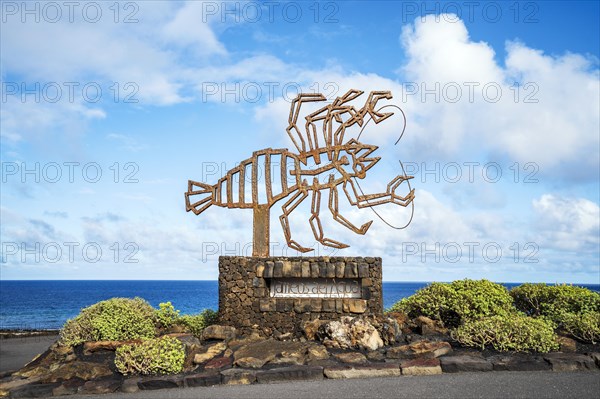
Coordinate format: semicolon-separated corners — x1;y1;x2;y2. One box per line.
60;298;156;346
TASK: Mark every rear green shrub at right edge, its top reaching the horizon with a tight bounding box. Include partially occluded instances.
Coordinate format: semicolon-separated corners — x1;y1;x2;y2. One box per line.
510;283;600;323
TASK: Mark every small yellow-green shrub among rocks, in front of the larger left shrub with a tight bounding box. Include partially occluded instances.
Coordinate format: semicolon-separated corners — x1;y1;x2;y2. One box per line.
115;336;185;375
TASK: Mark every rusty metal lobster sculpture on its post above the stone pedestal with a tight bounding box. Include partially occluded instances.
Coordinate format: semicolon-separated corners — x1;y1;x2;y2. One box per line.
185;90;414;257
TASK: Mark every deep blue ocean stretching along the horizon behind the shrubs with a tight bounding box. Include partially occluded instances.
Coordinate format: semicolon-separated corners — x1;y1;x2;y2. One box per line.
0;280;600;330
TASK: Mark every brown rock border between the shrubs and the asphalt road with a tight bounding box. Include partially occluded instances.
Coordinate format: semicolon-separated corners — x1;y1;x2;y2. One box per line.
0;334;600;398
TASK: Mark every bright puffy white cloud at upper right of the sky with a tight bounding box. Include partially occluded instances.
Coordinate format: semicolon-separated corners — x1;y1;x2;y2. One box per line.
401;16;600;180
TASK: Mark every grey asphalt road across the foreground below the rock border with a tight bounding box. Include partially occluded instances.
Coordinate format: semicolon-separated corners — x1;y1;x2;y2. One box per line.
69;371;600;399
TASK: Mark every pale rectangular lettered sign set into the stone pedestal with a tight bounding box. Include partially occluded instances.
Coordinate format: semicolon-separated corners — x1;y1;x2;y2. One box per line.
270;278;361;298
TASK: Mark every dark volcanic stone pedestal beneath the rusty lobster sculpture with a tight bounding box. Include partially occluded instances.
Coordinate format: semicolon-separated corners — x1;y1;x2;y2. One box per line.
219;256;383;335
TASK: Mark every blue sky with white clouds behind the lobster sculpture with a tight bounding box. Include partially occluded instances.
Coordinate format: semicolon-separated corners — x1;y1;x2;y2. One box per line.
0;1;600;284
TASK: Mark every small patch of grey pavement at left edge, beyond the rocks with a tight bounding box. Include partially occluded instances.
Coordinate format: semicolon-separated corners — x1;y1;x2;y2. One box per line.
0;335;58;373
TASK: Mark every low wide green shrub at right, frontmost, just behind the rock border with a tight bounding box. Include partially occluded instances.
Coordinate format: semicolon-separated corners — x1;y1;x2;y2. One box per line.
451;313;559;353
